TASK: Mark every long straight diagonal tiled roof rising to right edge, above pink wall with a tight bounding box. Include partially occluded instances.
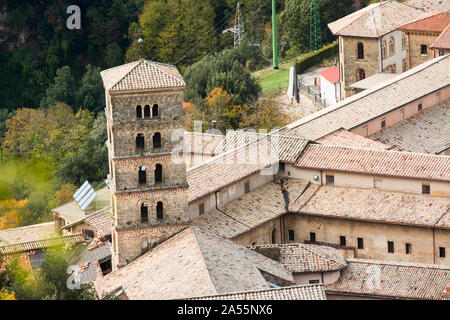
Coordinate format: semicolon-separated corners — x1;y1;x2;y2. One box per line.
287;55;450;141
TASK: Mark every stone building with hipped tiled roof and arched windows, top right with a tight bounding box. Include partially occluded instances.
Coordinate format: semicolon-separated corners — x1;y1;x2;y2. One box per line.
328;0;423;98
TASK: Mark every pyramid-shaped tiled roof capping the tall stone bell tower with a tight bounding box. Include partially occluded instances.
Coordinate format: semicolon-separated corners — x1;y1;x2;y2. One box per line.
100;59;186;92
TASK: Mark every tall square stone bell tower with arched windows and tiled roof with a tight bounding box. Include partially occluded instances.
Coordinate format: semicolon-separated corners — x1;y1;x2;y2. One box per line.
101;59;189;268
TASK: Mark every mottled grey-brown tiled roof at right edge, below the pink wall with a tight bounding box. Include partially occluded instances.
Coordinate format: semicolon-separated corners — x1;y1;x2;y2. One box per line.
370;102;450;154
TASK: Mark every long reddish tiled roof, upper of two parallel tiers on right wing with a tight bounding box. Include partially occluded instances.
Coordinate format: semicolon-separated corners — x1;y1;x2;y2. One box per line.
296;144;450;182
